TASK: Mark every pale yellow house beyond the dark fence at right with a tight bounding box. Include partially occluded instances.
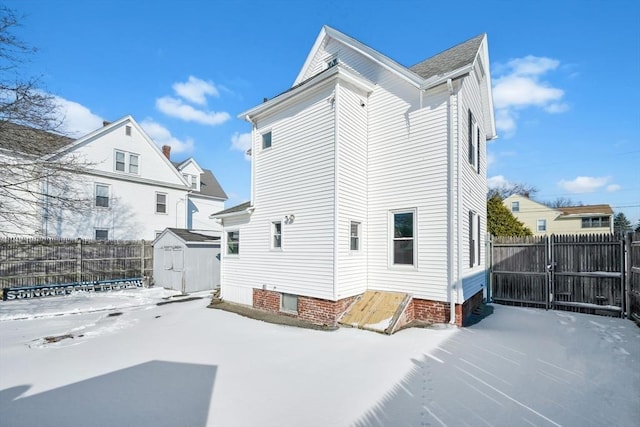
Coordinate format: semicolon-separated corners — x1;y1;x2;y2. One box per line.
503;194;613;236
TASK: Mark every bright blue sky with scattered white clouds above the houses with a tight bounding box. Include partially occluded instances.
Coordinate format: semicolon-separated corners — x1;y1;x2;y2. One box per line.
4;0;640;224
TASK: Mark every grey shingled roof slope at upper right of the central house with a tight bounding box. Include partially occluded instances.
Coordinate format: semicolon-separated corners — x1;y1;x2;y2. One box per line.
409;33;485;79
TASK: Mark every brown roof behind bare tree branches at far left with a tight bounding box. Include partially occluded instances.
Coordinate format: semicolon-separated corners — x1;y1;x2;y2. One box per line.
0;121;74;157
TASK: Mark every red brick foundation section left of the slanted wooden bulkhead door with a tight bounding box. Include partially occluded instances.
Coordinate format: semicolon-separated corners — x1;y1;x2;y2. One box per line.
253;289;356;326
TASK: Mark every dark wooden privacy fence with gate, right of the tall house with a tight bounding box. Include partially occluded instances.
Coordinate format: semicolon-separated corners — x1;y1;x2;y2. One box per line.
490;234;640;319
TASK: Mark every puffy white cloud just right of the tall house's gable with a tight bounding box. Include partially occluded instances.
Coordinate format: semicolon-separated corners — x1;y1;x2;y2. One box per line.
493;55;569;138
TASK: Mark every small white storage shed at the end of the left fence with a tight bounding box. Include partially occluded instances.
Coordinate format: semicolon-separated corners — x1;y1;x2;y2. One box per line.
153;228;220;294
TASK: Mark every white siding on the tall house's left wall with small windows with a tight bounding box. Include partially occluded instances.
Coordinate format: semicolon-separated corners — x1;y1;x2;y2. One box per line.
223;85;335;299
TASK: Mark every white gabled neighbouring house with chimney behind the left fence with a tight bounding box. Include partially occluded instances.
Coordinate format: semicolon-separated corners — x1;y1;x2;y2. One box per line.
0;116;227;240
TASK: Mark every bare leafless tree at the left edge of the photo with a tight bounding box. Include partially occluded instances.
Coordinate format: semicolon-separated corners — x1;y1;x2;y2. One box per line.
0;6;90;236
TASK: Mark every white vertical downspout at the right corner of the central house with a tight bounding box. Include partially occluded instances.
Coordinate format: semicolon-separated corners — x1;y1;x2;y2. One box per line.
447;79;459;324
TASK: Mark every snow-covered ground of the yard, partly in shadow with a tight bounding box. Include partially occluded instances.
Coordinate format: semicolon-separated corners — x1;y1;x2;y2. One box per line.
0;289;640;427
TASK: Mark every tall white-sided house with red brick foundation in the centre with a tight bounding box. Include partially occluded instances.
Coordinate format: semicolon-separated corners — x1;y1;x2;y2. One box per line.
212;26;496;324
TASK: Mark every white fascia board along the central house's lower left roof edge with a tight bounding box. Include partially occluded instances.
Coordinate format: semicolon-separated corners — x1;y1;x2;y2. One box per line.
238;64;375;119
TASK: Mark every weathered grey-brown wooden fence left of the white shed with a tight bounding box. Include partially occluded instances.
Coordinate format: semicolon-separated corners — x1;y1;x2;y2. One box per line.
0;239;153;289
